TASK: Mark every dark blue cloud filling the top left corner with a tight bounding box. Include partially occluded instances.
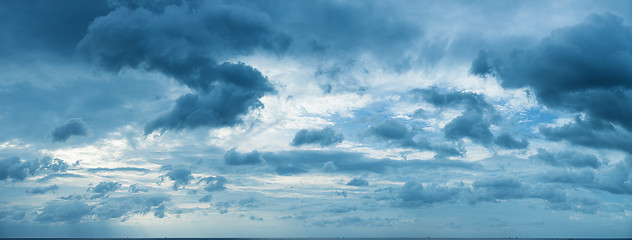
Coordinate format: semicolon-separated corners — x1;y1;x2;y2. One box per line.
0;0;111;60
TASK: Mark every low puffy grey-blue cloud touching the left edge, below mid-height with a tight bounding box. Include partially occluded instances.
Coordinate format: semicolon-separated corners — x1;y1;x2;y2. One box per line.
0;157;69;181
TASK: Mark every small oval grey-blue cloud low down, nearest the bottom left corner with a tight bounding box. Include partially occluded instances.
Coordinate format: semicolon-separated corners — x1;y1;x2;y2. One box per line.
35;201;93;223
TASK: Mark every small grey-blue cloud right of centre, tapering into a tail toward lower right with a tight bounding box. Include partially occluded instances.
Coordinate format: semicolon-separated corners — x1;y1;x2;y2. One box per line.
366;118;462;157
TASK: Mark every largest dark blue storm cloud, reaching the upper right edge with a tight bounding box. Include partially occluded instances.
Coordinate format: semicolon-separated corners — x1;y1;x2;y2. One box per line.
472;13;632;148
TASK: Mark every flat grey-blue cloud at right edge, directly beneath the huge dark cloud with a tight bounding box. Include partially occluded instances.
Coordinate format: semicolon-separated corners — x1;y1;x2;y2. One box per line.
539;116;632;153
